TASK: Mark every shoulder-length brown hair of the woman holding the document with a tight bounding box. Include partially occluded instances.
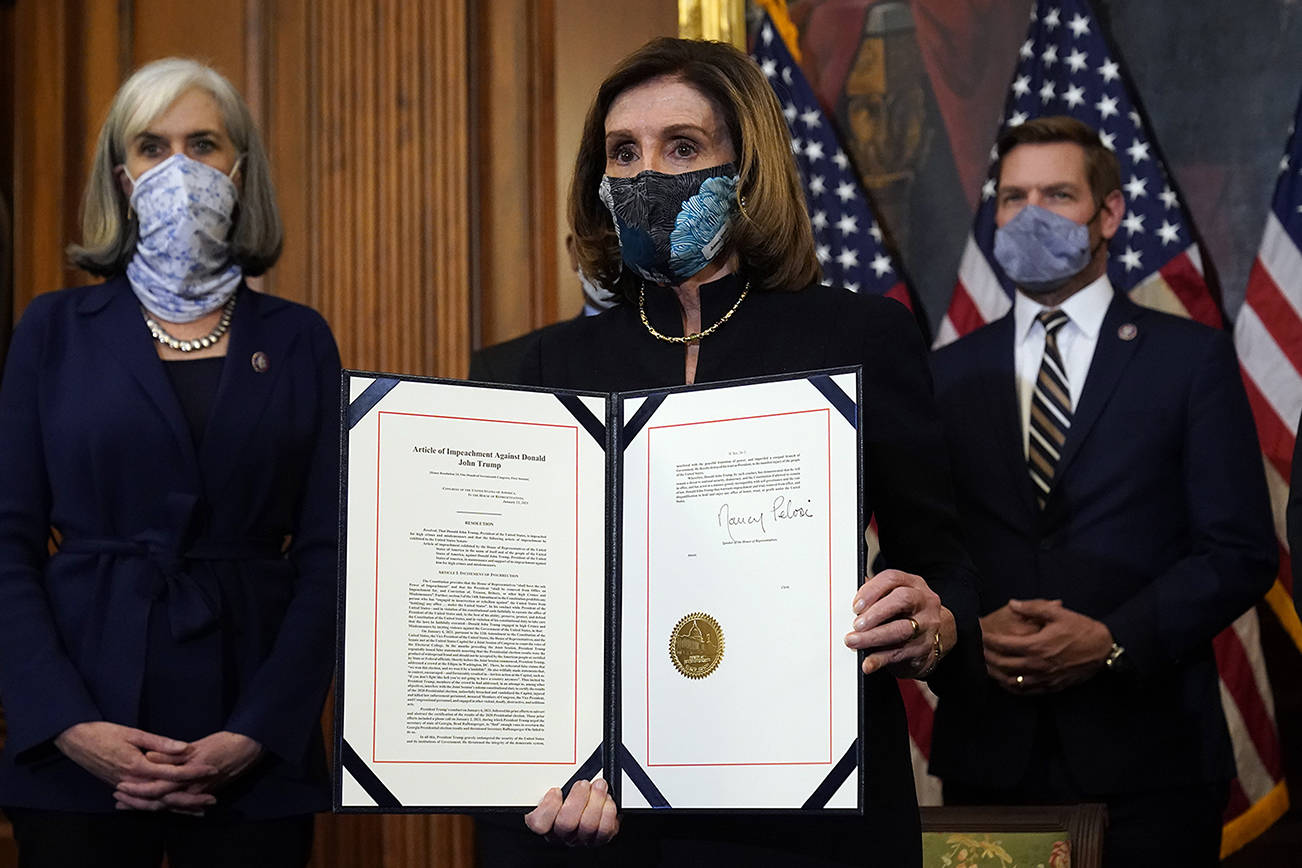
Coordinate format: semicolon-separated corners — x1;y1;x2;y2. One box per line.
569;38;822;298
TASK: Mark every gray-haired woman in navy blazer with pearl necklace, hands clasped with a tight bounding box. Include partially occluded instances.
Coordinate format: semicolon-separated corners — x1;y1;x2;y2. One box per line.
0;59;339;868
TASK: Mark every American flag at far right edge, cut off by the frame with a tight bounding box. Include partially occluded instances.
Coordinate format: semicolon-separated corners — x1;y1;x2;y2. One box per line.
1234;100;1302;666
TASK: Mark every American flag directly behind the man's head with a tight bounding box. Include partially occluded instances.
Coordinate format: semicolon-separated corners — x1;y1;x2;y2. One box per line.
936;0;1221;346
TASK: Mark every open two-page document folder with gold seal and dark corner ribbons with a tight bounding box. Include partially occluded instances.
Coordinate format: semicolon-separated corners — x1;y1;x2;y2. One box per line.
335;368;865;812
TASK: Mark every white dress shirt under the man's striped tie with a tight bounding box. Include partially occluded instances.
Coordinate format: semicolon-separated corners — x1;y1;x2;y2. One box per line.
1013;275;1112;454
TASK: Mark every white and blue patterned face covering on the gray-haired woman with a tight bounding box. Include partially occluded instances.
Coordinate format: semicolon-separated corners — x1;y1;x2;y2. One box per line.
122;154;242;323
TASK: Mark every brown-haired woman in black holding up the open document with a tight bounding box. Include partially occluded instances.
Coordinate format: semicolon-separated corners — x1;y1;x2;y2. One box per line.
480;39;983;865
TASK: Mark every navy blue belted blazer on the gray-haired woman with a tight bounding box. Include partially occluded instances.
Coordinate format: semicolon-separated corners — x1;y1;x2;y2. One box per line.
0;277;340;817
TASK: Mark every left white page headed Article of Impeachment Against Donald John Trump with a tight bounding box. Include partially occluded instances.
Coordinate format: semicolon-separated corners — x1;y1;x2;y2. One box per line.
344;381;604;807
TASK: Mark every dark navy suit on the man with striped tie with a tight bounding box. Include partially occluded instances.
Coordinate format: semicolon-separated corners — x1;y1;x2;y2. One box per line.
931;294;1276;794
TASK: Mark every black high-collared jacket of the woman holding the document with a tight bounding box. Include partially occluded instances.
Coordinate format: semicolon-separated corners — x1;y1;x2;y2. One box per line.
493;277;983;867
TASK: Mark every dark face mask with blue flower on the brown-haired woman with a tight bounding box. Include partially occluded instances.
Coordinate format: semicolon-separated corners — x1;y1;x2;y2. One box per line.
598;163;737;284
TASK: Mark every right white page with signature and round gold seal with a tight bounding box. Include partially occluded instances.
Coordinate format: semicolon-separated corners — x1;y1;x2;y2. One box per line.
621;376;861;808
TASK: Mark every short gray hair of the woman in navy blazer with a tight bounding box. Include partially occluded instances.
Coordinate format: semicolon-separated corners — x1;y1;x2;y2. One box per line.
68;57;284;277
